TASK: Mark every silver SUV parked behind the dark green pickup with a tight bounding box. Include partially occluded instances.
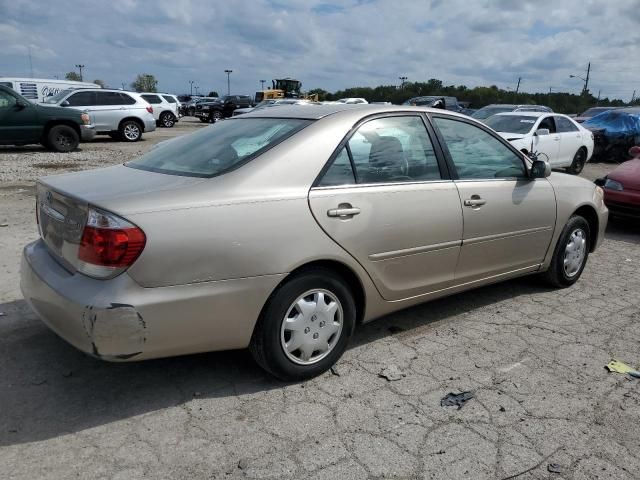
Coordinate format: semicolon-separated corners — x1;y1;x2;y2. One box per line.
42;88;156;142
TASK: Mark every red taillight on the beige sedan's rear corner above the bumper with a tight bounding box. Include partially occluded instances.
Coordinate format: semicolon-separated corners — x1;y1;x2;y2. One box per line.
78;226;146;268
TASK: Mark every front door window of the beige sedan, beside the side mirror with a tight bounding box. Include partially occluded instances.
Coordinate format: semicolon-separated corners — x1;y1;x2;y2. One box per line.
434;117;526;180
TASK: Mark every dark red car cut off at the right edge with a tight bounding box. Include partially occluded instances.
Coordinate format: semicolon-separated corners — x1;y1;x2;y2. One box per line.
596;146;640;219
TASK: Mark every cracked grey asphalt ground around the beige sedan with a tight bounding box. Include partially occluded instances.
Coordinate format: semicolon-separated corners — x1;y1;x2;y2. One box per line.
0;124;640;480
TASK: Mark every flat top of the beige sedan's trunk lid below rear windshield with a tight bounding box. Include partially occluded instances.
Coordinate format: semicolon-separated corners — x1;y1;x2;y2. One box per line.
40;165;209;214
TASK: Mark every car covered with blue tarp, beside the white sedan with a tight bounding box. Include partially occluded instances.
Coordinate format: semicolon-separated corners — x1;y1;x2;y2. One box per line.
582;107;640;162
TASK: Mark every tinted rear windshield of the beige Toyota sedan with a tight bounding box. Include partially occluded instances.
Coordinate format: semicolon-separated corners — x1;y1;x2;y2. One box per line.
125;118;311;178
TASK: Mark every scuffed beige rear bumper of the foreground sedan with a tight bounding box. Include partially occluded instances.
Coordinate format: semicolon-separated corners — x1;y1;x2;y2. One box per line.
20;240;284;361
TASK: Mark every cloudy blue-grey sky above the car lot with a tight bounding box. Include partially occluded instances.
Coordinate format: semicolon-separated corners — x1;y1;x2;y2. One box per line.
0;0;640;101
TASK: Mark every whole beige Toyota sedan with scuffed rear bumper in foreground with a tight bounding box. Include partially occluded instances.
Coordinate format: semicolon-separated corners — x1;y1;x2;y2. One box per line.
21;105;607;380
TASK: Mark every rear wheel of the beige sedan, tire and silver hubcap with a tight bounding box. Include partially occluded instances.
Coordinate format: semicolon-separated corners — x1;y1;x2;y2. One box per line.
249;268;356;381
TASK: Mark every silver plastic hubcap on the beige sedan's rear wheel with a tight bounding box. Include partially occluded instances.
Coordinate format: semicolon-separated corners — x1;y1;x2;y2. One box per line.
280;289;344;365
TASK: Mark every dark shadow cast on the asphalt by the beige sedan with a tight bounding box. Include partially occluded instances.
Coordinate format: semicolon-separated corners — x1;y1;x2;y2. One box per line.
0;279;547;447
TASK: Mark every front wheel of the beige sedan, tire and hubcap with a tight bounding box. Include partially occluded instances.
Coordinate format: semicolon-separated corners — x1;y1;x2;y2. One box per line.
542;215;591;288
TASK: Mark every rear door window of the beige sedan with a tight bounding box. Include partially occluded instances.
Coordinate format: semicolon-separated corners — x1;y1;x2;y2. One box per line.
348;116;441;183
